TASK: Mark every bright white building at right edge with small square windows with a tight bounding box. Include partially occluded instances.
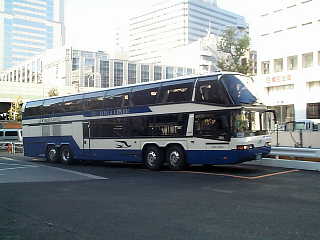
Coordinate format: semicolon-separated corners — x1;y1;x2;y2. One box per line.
253;0;320;122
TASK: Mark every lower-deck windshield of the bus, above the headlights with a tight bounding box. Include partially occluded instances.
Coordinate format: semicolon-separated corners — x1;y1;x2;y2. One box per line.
231;110;275;137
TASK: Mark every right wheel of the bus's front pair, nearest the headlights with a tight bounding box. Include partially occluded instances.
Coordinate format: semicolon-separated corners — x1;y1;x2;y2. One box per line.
166;145;188;171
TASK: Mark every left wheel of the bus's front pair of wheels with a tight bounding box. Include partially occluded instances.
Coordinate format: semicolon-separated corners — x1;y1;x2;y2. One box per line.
143;145;164;170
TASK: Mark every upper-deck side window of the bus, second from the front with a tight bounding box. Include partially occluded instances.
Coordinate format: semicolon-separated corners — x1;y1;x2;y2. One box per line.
158;79;195;104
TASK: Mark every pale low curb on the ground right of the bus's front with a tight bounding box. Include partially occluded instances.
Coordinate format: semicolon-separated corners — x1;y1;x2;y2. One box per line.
244;158;320;171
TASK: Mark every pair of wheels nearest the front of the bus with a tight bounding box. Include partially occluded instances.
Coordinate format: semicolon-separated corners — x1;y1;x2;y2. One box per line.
143;145;187;170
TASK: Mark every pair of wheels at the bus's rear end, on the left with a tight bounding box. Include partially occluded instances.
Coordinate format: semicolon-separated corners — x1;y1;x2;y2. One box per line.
46;145;74;165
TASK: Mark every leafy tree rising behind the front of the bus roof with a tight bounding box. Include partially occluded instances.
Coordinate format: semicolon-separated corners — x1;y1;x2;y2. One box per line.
217;27;251;74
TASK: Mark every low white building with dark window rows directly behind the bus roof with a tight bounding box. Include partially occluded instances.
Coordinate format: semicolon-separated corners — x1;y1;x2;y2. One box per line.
0;47;195;102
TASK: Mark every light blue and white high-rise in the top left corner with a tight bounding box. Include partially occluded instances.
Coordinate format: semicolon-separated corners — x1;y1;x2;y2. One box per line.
0;0;65;71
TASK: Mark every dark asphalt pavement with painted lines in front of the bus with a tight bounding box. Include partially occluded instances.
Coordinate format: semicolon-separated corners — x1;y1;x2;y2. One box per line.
0;154;320;240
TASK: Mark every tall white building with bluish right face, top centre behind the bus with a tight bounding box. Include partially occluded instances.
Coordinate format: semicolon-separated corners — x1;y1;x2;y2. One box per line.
129;0;247;63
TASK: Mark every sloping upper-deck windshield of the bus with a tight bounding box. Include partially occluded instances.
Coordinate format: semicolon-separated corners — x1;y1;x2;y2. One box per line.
221;74;257;104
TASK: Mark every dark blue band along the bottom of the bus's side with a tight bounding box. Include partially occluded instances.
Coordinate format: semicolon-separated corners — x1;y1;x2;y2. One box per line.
23;136;271;165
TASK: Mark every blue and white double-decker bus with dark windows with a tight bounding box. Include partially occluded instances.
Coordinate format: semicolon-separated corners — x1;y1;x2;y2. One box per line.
22;72;275;170
